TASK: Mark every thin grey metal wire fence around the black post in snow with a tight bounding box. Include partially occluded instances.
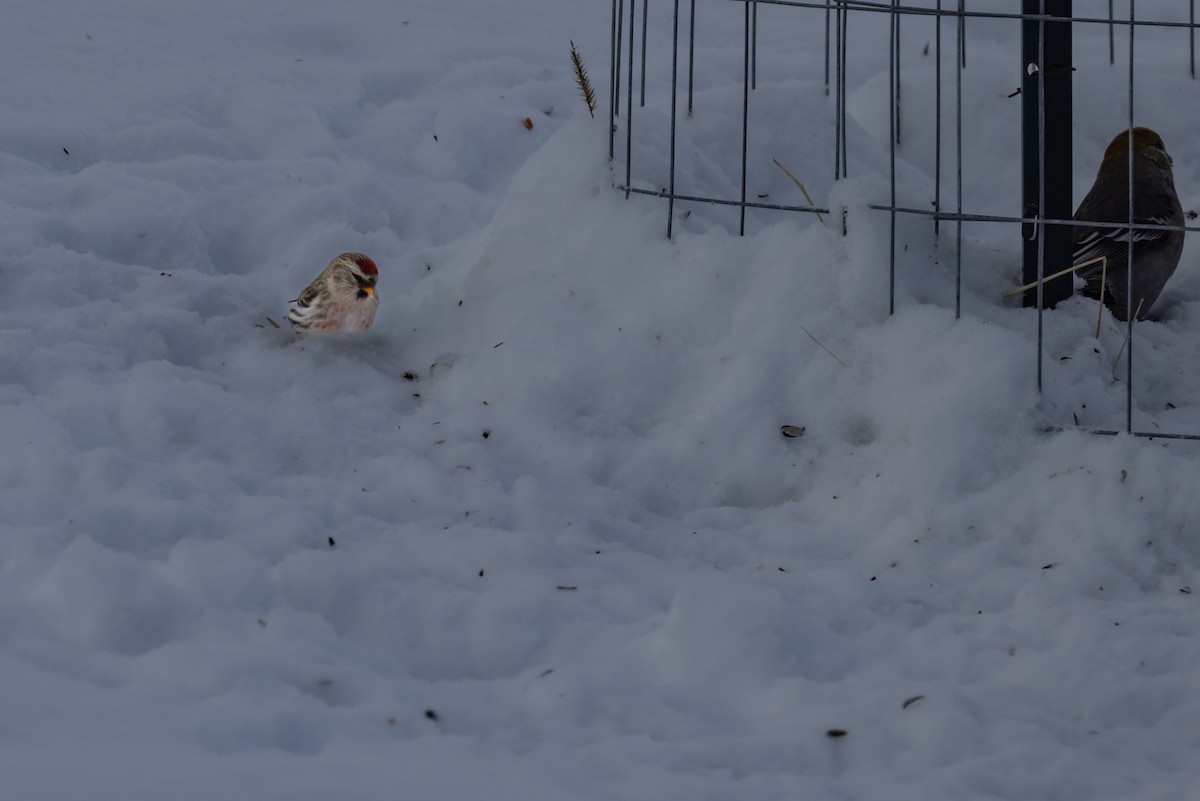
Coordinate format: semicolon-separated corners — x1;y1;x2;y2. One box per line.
608;0;1200;440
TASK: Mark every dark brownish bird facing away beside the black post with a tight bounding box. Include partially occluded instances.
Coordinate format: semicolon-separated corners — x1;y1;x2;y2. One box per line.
1072;127;1183;320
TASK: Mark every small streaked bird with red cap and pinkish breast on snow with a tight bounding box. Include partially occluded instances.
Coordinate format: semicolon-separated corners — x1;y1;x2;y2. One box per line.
288;253;379;335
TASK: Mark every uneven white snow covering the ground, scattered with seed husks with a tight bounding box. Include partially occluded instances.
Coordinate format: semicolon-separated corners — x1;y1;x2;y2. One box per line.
0;0;1200;801
